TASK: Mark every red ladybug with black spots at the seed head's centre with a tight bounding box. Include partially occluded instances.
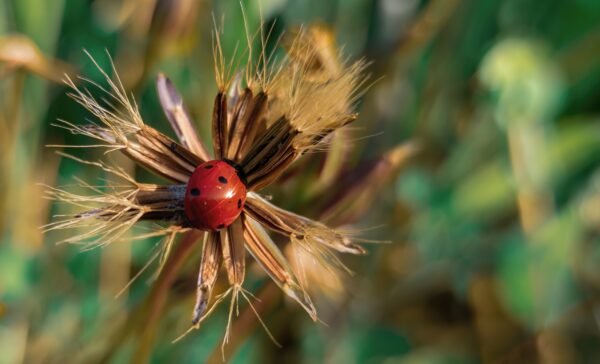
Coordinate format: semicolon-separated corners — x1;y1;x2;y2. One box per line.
184;160;246;231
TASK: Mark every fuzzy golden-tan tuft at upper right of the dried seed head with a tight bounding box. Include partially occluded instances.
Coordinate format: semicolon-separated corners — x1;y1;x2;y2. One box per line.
270;30;365;151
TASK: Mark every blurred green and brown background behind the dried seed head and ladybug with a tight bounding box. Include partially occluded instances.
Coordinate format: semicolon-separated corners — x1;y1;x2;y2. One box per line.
0;0;600;363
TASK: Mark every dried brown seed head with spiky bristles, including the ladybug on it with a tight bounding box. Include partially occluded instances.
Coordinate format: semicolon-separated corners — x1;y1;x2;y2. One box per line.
48;25;364;342
